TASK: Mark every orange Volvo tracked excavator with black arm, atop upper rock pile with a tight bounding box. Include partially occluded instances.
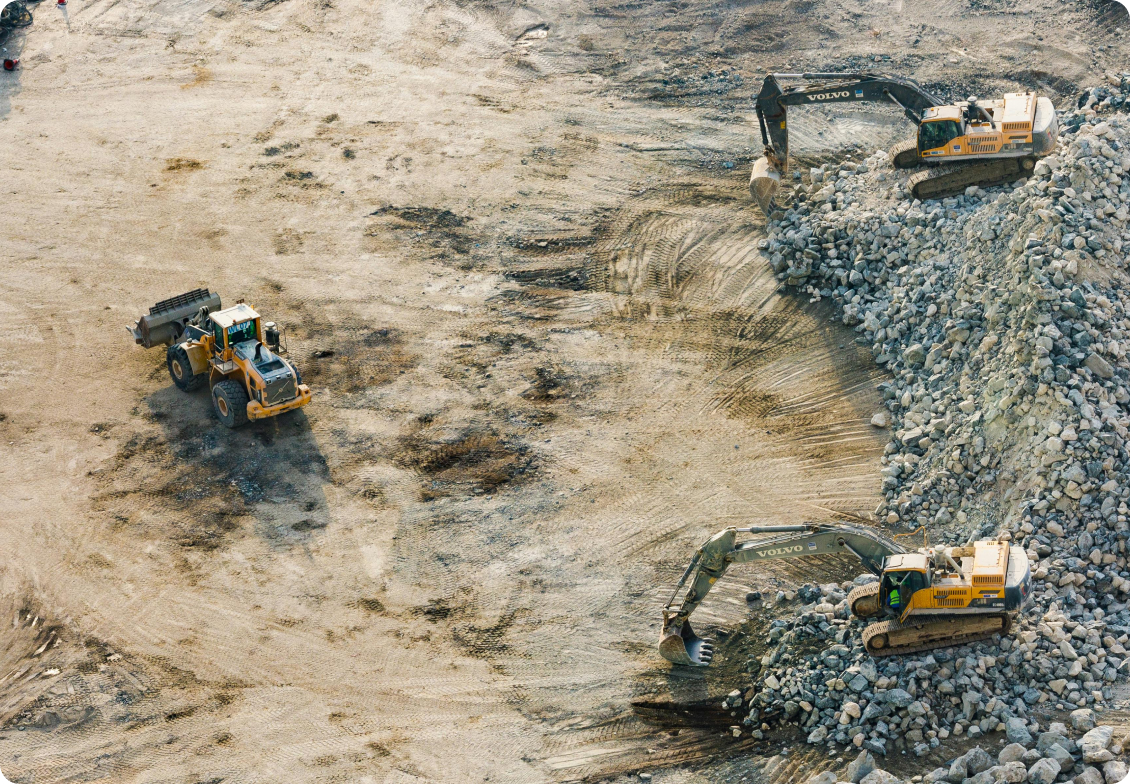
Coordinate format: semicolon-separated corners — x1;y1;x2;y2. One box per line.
749;73;1059;215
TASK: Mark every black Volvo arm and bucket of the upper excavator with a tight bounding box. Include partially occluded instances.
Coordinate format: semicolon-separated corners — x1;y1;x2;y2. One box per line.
749;73;944;214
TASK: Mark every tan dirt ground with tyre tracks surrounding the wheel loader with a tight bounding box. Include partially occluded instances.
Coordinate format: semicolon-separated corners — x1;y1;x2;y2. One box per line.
0;0;1130;784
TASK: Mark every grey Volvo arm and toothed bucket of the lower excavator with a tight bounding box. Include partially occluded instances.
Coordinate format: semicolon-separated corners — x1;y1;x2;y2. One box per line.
659;524;906;667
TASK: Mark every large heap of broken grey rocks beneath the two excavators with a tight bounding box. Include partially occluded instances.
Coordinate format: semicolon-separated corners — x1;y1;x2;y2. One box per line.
725;75;1130;768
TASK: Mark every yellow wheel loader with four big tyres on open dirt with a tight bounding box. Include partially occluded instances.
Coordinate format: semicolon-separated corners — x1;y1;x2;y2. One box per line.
130;288;313;427
